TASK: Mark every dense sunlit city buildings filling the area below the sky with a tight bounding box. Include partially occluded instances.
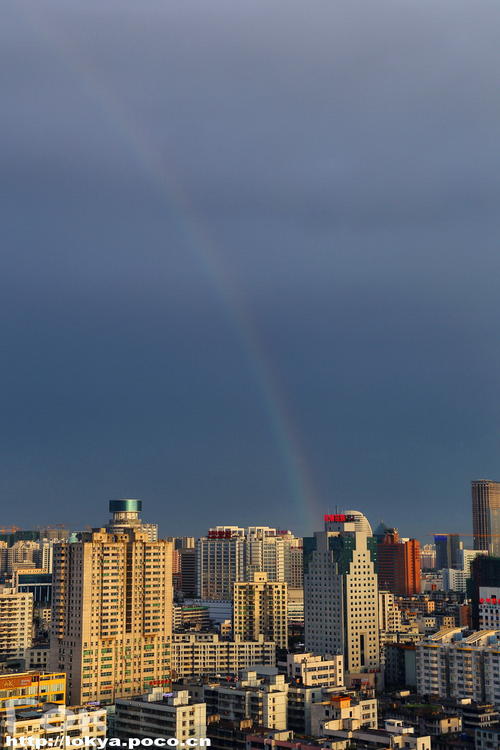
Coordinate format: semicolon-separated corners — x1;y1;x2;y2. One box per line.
0;479;500;750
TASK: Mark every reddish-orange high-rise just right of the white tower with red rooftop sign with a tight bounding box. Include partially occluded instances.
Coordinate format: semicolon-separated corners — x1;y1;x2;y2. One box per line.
377;529;421;596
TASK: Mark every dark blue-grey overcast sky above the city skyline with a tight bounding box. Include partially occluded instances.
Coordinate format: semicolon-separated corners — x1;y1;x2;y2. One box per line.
0;0;500;541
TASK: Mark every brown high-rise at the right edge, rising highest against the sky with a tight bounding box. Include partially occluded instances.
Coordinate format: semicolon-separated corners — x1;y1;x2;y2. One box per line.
472;479;500;557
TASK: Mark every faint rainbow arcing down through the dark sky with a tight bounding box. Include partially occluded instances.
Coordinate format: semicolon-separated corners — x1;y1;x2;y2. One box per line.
19;4;322;531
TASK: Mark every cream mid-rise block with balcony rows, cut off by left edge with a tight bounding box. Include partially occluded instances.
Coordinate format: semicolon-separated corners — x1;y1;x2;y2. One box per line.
0;588;33;661
